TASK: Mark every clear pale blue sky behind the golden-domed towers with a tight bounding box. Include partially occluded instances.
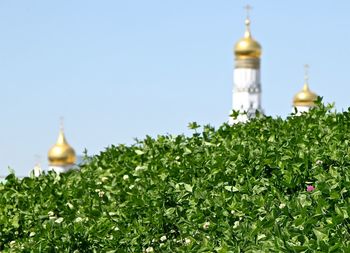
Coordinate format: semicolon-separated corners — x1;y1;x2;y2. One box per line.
0;0;350;175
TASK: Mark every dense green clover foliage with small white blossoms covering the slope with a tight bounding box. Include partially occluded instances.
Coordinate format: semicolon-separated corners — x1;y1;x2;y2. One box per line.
0;104;350;252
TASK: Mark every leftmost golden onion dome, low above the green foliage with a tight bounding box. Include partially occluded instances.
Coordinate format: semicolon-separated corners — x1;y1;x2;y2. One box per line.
48;129;77;166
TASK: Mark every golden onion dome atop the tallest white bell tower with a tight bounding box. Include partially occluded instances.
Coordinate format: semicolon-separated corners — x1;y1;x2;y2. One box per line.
234;18;262;59
